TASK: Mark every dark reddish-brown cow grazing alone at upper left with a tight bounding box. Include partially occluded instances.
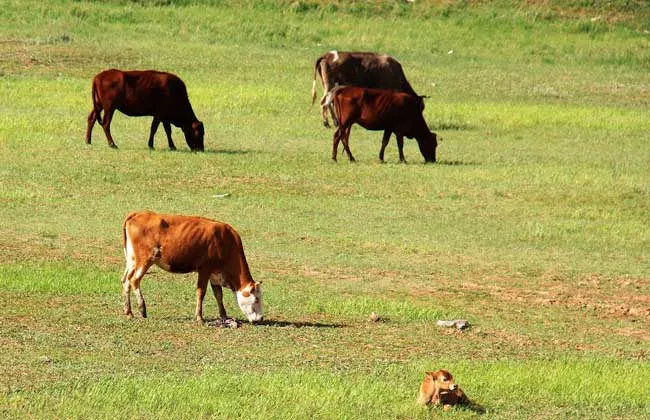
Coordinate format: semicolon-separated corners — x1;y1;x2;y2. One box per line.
86;69;205;152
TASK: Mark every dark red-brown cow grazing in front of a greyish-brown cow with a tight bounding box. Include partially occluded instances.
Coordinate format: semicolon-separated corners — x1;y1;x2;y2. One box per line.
326;86;438;162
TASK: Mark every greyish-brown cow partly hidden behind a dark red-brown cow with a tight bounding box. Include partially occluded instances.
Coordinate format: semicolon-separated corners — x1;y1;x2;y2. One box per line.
311;51;424;127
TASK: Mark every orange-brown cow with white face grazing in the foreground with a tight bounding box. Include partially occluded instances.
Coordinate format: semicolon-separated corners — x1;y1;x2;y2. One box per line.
122;211;262;322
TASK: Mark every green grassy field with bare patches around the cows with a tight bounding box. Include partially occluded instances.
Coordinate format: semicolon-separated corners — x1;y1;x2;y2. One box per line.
0;0;650;419
